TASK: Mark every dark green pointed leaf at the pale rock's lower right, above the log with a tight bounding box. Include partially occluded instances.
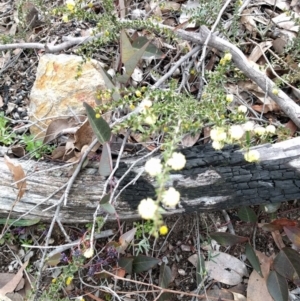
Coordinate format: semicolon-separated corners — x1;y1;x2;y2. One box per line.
83;102;111;144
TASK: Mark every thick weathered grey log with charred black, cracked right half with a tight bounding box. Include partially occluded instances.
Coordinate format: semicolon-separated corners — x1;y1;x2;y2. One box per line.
0;137;300;223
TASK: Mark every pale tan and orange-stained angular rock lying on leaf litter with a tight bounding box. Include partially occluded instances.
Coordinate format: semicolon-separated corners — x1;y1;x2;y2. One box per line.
28;54;106;138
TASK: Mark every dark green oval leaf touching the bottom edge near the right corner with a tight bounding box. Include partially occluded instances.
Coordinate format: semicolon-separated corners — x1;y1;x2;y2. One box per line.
267;271;289;301
